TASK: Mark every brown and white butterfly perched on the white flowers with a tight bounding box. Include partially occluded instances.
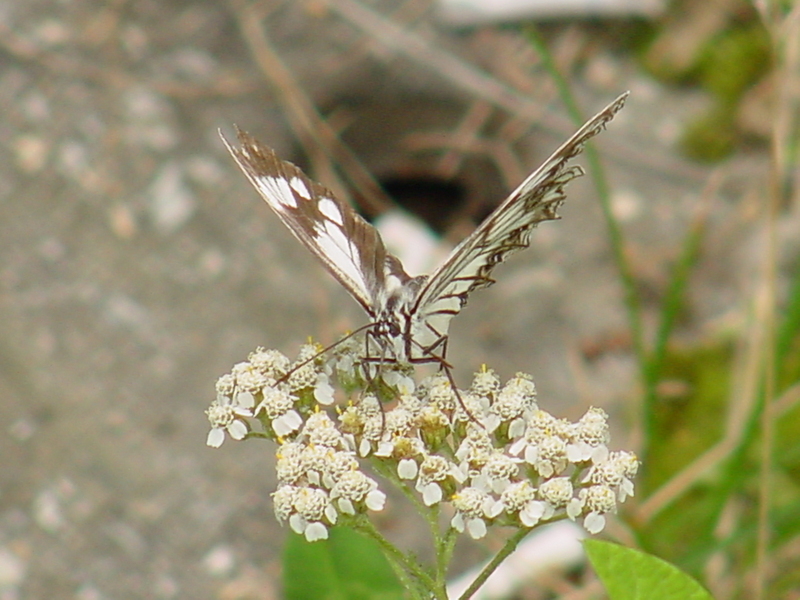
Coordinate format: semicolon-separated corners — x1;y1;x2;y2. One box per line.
220;92;628;367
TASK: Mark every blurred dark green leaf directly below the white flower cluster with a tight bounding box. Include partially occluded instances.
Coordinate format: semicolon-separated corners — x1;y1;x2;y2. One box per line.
283;527;403;600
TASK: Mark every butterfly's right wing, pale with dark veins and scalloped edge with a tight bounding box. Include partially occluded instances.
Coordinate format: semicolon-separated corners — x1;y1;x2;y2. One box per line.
412;92;628;348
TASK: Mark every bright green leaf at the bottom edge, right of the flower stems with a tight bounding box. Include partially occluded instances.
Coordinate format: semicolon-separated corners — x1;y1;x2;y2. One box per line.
583;540;713;600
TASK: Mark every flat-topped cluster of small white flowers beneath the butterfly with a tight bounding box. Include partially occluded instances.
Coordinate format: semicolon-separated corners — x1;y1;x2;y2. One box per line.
206;344;639;541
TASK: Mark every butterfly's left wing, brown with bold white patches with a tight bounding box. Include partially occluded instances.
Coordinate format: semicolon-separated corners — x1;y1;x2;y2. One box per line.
220;128;408;317
